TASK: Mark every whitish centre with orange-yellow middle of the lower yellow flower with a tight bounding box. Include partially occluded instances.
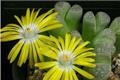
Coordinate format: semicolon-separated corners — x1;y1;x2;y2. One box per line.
58;51;74;69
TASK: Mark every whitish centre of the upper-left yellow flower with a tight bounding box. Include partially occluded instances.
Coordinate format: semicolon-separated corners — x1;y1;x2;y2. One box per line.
19;24;39;40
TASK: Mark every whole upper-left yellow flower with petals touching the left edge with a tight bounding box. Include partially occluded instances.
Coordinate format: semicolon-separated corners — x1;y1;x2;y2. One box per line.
0;8;62;66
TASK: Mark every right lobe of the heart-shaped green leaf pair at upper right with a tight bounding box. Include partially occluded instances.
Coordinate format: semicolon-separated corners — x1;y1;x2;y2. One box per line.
96;12;110;33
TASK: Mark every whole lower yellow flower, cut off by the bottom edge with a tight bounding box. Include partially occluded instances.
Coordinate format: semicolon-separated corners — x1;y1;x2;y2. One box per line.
35;34;96;80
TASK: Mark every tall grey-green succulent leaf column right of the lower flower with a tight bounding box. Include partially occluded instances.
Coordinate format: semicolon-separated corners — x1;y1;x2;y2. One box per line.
84;28;116;80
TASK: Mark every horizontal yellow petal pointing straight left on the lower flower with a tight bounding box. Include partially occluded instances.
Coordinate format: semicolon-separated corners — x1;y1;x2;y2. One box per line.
35;61;57;69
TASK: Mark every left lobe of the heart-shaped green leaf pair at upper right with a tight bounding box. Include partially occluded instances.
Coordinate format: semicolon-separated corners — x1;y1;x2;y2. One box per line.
82;11;96;41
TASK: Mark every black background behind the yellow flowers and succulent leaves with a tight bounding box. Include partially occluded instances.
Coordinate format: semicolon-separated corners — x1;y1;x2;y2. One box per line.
1;1;120;80
